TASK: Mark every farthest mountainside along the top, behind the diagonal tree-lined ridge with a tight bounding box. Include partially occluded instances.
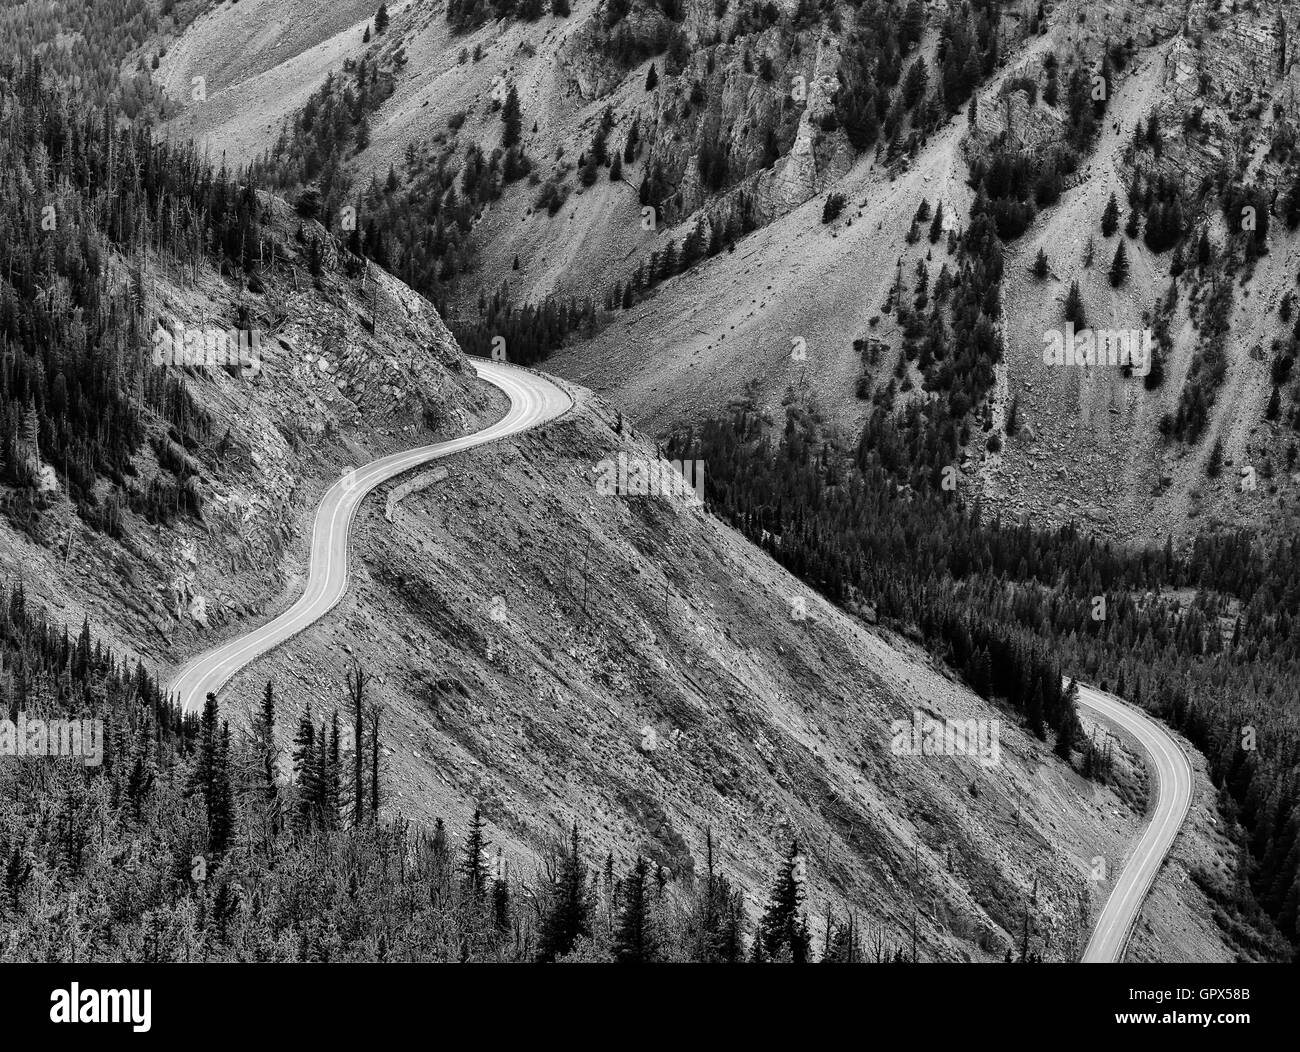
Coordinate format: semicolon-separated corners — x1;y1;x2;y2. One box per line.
156;0;1003;332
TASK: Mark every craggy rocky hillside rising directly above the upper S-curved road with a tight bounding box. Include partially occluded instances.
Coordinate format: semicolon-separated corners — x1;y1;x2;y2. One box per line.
0;154;503;691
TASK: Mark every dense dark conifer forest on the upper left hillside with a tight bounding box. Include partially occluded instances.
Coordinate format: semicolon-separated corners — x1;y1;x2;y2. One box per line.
0;53;265;536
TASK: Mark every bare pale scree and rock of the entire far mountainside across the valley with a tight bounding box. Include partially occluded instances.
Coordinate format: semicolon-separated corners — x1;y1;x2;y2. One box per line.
147;0;1300;548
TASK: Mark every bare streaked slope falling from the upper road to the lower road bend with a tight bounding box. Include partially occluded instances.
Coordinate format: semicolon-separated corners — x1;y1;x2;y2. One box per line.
200;377;1232;960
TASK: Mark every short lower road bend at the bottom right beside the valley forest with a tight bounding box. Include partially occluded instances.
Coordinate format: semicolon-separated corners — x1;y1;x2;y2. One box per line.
1079;683;1192;964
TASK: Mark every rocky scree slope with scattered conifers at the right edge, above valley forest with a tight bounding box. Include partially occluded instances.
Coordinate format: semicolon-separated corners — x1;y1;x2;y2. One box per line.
980;4;1300;540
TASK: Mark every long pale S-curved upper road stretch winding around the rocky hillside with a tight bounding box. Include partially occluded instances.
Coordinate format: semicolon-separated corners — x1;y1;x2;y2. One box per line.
168;359;572;711
